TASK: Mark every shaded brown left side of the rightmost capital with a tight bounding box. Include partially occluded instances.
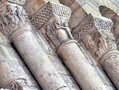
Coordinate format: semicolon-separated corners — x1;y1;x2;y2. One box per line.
72;15;101;58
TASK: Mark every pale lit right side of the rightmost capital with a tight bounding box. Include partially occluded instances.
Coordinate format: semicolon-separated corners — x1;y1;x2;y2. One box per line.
94;18;117;57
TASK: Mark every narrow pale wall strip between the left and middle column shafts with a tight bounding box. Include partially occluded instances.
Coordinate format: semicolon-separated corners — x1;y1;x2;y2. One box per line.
34;29;79;90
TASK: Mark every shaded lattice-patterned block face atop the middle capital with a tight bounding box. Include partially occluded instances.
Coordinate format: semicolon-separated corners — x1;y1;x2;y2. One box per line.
30;3;52;30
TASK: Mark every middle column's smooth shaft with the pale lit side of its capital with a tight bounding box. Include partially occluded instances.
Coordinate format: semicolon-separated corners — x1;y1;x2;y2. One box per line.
47;4;115;90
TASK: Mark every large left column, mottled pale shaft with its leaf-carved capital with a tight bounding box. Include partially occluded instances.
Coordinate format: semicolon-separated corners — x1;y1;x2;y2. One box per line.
0;0;69;90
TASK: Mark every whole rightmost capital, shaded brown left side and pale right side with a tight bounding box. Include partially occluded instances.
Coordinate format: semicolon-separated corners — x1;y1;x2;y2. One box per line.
72;15;117;60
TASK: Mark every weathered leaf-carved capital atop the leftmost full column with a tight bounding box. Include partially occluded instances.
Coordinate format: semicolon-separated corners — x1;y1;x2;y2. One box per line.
0;0;28;37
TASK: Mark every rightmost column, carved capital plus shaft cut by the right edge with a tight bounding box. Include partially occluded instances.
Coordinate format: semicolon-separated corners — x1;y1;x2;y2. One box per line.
72;11;119;89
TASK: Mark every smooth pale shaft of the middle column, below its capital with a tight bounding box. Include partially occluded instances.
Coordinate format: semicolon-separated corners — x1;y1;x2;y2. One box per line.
58;41;114;90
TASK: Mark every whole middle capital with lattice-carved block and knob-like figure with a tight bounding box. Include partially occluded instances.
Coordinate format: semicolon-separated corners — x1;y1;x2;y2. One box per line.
31;3;72;50
